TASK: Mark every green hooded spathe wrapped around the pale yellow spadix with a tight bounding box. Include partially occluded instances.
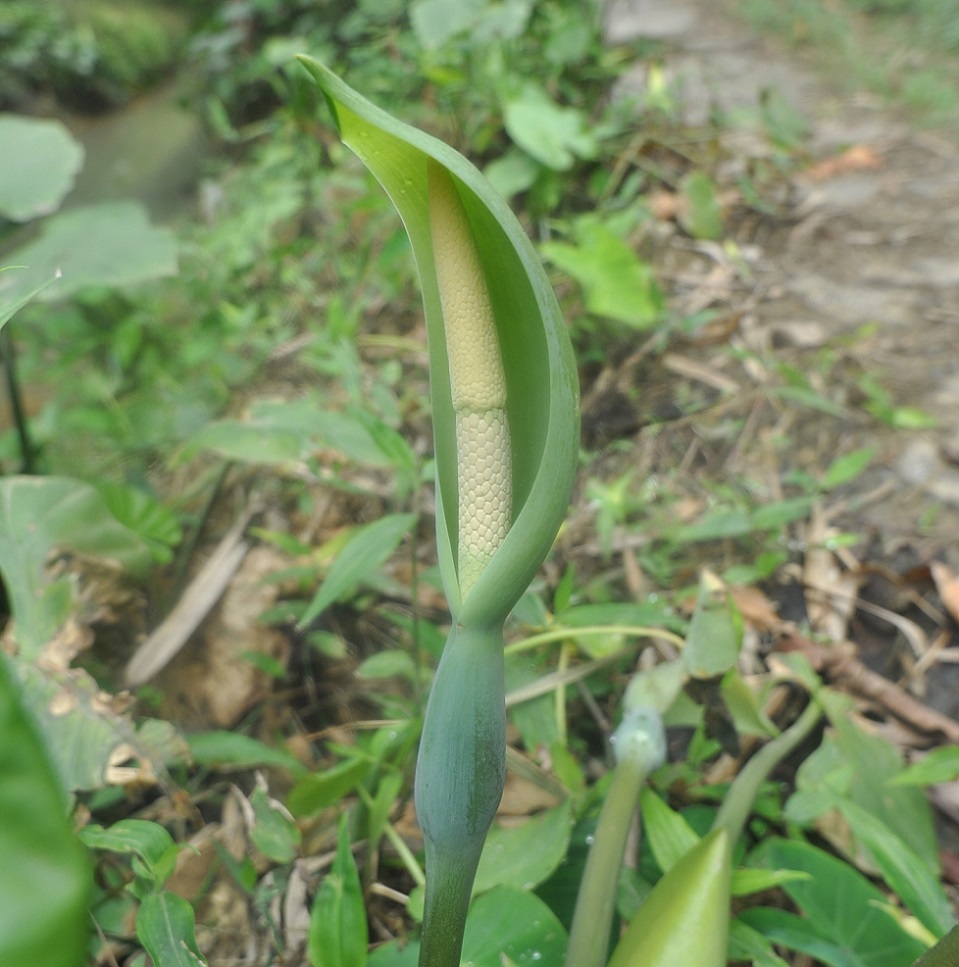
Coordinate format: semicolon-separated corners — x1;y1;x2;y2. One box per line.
300;57;579;625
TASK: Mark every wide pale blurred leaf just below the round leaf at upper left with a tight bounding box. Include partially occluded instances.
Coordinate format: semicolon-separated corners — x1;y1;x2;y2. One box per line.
8;201;177;302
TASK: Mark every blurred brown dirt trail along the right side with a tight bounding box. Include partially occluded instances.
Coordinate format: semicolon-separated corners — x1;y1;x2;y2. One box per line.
608;0;959;716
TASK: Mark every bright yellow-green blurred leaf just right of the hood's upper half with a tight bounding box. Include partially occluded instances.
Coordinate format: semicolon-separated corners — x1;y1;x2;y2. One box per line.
540;220;663;329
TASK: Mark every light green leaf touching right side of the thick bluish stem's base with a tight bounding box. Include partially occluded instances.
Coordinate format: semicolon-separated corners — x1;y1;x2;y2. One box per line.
473;800;572;894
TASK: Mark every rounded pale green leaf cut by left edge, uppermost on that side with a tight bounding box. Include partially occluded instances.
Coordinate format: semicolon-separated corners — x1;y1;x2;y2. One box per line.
0;114;83;222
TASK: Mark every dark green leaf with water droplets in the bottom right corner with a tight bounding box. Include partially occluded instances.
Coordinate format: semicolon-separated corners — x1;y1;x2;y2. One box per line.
743;837;924;967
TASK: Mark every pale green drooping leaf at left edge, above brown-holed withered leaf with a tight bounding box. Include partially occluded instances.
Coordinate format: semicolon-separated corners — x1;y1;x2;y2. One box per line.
0;477;150;658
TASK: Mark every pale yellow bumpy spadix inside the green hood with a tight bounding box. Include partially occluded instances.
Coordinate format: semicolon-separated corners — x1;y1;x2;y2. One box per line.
428;160;513;597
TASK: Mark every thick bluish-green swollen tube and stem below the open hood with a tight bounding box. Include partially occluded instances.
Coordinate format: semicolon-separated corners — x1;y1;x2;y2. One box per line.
415;626;506;967
